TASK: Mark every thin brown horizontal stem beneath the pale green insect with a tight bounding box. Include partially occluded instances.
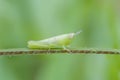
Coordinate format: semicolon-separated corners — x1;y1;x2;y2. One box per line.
0;49;120;55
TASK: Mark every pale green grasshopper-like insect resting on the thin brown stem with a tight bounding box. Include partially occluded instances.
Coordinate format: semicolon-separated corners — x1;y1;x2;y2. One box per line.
28;31;81;49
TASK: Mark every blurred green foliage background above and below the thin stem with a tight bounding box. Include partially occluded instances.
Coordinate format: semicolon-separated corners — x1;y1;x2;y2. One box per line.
0;0;120;80
